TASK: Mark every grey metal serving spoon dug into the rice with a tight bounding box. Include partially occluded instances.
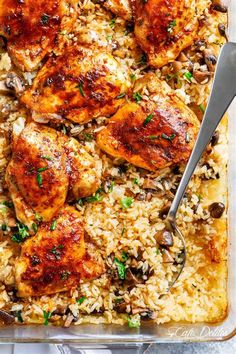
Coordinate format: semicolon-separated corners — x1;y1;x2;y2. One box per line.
166;43;236;289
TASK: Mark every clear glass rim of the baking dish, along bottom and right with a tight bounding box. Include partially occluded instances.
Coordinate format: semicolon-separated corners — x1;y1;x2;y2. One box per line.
0;0;236;353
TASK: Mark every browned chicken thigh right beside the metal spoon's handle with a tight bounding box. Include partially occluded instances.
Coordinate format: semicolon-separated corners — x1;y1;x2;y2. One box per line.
97;74;199;171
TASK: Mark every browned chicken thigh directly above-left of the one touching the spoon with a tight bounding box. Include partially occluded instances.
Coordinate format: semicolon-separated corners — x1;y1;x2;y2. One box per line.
22;46;129;123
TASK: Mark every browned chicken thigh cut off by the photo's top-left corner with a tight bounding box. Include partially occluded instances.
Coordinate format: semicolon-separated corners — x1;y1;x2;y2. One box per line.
0;0;76;71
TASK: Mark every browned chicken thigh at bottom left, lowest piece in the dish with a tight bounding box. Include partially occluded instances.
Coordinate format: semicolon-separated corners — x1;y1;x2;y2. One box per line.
15;206;104;297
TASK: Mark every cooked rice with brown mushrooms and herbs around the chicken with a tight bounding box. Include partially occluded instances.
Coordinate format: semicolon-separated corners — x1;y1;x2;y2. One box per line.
0;0;227;327
